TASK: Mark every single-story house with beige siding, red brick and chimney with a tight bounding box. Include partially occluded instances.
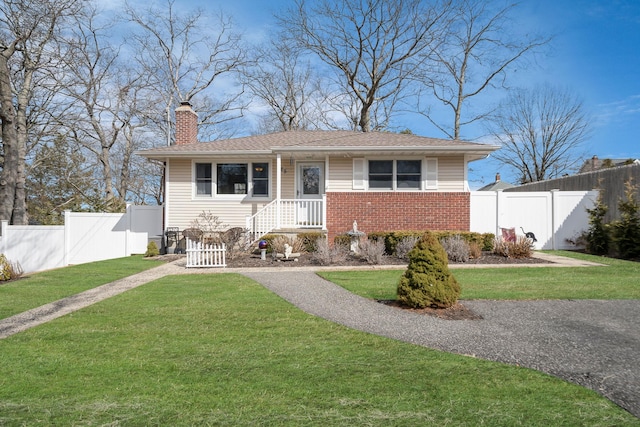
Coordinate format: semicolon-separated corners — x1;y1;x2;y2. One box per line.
138;103;499;246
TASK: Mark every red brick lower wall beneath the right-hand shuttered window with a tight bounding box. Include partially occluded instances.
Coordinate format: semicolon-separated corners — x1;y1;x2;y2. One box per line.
327;192;470;242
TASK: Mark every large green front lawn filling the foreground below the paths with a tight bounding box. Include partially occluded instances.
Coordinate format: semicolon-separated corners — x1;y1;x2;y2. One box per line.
0;274;640;426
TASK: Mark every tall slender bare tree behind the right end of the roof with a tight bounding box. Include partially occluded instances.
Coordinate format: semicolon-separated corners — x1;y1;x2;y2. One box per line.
418;0;550;139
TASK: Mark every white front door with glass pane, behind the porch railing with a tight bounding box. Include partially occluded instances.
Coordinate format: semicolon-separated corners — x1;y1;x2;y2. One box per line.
296;163;324;226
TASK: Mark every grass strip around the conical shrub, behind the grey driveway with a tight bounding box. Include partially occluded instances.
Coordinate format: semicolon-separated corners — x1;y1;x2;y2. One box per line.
319;251;640;300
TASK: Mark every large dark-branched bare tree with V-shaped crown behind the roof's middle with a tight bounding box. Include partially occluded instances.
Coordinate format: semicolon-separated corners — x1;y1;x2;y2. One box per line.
279;0;450;132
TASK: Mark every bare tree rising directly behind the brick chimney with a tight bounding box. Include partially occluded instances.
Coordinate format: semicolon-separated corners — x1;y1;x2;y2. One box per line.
126;0;247;144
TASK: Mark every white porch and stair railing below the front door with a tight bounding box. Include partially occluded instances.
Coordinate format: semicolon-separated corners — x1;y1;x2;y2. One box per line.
246;197;326;243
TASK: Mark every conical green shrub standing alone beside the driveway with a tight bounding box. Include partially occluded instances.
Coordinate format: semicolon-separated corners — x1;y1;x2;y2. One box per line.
398;232;460;308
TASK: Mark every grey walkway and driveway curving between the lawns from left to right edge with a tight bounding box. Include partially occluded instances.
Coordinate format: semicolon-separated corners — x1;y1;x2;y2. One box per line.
0;254;640;417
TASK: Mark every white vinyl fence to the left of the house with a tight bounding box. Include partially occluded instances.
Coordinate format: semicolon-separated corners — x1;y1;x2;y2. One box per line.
0;206;163;273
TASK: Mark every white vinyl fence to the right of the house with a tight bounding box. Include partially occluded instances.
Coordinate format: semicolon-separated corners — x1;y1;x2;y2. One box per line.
470;190;598;250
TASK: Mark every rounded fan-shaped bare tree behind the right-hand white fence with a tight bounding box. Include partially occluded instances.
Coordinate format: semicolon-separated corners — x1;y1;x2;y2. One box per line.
489;85;590;184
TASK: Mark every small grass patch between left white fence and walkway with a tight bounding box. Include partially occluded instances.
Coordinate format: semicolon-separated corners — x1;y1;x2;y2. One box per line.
0;255;162;319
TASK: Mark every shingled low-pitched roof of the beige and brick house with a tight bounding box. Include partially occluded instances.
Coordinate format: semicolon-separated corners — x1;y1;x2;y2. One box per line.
137;130;500;160
